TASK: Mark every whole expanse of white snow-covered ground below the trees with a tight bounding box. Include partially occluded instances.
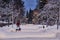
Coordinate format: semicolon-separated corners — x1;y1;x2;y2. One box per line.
0;24;60;38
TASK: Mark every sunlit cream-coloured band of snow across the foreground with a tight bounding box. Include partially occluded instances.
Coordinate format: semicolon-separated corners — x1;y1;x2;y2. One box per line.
0;32;56;39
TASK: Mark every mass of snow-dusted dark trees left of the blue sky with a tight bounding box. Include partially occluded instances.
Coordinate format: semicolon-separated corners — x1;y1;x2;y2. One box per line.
0;0;24;21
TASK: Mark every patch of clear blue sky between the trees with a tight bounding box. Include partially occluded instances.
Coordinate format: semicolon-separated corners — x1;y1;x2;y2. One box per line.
23;0;37;11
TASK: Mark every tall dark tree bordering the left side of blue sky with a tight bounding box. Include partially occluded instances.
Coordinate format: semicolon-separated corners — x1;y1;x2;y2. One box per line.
14;0;24;21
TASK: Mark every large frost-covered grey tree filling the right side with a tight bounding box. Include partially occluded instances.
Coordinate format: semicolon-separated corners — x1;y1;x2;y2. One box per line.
38;0;59;25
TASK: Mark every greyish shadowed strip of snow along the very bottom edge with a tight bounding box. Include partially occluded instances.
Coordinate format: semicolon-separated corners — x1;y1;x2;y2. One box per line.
0;38;60;40
